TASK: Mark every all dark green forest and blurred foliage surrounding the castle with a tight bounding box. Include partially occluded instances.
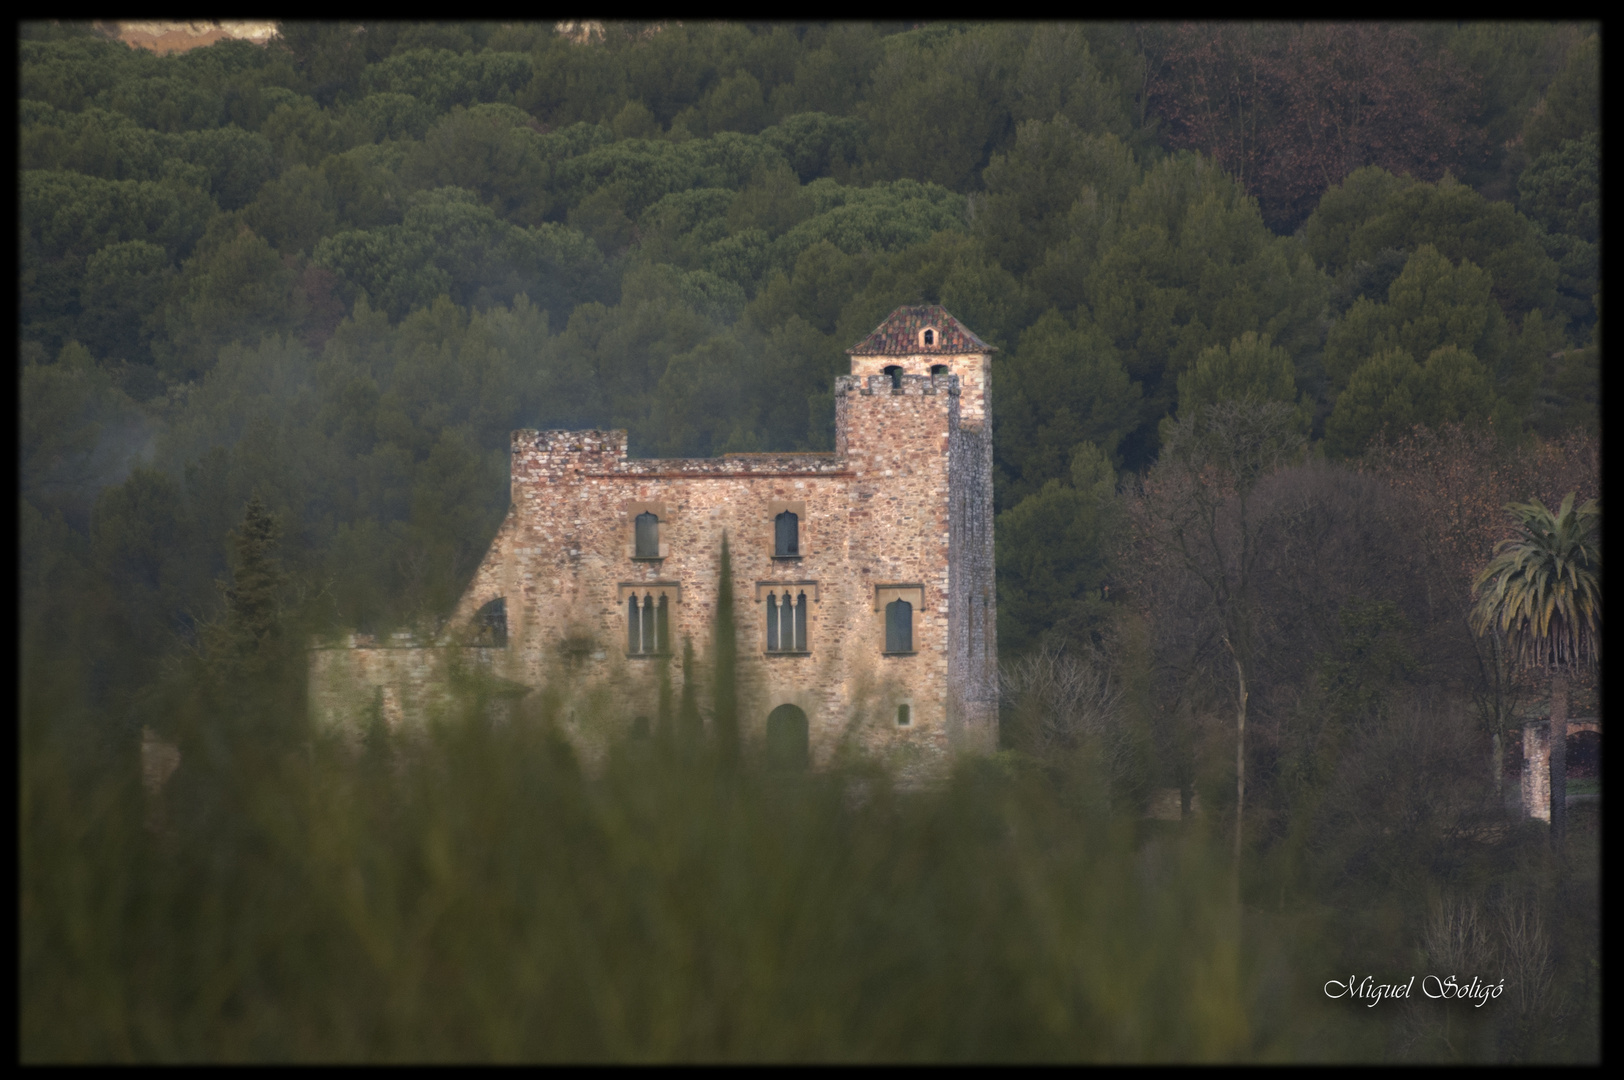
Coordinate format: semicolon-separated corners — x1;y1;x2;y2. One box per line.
18;23;1600;1059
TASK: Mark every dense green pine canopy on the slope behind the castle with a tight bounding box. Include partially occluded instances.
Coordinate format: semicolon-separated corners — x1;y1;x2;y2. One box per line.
18;23;1600;704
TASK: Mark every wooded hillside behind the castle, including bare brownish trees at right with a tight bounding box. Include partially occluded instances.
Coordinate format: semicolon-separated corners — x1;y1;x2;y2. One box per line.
18;21;1601;1059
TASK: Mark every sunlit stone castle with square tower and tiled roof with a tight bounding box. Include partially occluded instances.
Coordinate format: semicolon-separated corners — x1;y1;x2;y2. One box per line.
310;305;997;778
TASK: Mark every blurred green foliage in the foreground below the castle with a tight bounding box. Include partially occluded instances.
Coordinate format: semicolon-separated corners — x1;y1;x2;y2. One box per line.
19;669;1595;1061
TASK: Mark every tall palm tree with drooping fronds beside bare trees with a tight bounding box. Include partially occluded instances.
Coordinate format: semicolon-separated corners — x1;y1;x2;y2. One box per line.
1471;492;1601;845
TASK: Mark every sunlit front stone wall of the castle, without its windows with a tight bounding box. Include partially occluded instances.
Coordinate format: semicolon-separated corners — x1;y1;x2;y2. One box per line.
438;367;958;773
